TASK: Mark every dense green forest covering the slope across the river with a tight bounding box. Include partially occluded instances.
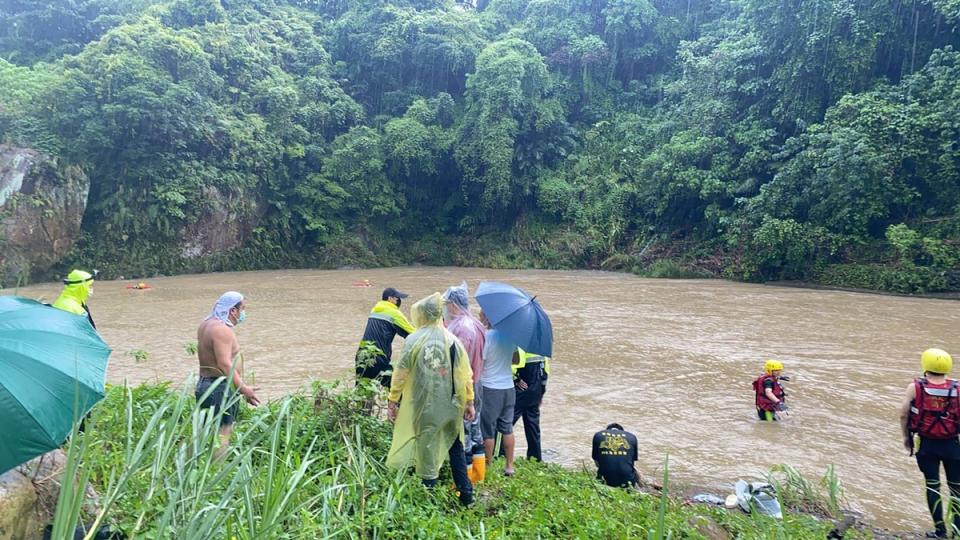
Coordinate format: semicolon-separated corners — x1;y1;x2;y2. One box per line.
0;0;960;292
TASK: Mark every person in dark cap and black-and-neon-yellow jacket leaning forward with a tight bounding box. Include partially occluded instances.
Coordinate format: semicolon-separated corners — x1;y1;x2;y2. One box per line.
355;287;414;388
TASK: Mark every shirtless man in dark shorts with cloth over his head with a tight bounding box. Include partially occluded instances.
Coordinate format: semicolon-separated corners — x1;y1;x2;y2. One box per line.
196;291;260;457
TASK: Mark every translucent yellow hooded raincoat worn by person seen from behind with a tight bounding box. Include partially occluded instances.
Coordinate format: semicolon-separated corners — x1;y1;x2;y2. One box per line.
387;293;473;480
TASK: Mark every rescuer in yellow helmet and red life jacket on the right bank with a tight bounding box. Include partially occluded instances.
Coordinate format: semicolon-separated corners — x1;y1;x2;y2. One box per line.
900;349;960;538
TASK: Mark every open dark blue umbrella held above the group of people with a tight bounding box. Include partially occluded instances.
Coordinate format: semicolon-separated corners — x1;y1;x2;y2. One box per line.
476;281;553;356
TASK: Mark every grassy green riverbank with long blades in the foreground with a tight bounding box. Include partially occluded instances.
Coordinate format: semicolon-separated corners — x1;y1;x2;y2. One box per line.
48;384;864;539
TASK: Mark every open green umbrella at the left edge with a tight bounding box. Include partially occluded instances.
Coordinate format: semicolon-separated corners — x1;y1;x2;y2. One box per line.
0;296;110;474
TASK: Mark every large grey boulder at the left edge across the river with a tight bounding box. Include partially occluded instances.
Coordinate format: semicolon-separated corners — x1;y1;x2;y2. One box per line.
0;144;90;286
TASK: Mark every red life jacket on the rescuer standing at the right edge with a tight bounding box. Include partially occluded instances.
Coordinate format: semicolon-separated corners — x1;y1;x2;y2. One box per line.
907;378;960;439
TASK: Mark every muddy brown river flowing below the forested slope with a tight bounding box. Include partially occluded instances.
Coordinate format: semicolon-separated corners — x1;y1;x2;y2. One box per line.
3;267;960;530
